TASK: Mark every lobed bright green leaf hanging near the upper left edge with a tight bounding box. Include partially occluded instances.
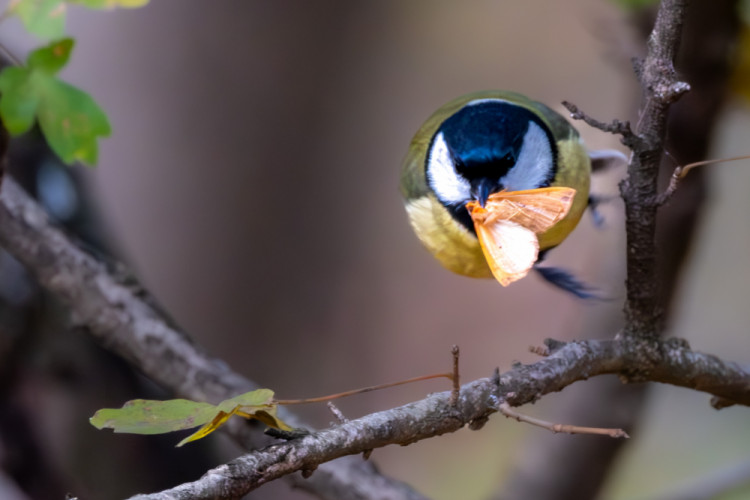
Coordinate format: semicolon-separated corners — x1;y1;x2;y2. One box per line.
0;38;112;165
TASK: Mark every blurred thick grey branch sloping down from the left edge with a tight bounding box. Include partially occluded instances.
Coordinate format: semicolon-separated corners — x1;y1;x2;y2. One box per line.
0;178;422;499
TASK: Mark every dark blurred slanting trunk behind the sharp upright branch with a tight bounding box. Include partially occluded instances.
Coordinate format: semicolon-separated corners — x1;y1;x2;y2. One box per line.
497;0;740;500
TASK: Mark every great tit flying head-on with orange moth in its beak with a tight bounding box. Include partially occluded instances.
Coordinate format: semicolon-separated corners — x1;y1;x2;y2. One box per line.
401;91;619;297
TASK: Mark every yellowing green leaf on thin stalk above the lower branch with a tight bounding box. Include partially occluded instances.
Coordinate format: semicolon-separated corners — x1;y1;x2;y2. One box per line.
90;389;291;446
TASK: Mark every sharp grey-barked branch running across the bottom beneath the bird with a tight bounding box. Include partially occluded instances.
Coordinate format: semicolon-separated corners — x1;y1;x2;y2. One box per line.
132;339;750;500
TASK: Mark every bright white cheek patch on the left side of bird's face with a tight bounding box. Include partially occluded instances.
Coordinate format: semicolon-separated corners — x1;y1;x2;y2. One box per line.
427;132;471;204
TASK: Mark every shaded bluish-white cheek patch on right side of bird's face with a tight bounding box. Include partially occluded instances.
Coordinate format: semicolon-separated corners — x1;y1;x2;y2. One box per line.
500;122;554;191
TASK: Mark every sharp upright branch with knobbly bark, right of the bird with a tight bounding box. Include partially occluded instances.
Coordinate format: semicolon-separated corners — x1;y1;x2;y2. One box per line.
620;0;690;337
